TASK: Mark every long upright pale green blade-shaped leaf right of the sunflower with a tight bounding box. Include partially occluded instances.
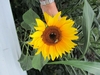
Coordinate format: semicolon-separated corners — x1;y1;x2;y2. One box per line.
82;0;95;56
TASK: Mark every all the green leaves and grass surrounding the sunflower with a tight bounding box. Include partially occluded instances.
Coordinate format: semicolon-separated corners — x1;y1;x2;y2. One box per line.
10;0;100;75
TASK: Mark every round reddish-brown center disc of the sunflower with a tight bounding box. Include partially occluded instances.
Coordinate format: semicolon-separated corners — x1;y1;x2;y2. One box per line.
42;26;61;45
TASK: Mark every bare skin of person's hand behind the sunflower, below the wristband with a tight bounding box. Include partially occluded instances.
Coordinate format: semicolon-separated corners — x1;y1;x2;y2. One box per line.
41;2;58;16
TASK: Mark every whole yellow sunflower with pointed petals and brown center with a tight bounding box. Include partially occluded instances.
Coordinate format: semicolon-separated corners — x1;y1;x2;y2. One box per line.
29;12;78;60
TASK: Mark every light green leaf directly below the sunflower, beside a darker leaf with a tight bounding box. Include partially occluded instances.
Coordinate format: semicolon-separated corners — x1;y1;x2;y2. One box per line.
32;53;48;70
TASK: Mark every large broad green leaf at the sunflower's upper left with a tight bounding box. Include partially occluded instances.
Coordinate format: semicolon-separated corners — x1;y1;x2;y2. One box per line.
23;9;39;30
